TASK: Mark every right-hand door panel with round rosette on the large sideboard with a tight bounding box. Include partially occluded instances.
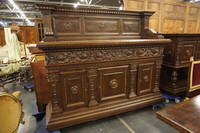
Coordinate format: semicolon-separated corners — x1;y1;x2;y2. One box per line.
137;63;155;95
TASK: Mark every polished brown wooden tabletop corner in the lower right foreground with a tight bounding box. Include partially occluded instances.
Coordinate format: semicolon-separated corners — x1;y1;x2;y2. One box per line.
156;95;200;133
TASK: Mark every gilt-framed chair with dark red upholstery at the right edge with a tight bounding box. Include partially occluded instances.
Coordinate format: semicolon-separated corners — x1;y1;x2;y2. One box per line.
187;57;200;98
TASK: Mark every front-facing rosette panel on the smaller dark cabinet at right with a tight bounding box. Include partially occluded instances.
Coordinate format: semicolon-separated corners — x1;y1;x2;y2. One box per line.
181;42;195;63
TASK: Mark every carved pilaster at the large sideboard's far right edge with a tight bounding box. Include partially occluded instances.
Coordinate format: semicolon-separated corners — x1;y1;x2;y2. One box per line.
153;60;162;92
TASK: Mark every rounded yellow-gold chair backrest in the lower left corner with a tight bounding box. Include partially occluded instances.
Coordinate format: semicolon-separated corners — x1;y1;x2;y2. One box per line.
0;92;23;133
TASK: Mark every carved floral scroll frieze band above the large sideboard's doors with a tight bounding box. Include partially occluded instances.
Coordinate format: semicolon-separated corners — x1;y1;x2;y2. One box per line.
46;47;163;65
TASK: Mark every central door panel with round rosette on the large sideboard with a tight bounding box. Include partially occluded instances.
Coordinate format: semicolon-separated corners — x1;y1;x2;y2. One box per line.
98;66;128;102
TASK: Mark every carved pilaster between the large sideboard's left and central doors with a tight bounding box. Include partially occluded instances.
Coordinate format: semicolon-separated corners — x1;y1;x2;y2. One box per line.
88;68;98;107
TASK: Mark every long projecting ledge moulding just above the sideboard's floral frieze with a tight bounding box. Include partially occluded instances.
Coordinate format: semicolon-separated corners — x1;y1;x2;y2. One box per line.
37;39;171;51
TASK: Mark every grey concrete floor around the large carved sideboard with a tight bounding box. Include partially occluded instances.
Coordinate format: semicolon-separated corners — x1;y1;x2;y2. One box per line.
0;83;178;133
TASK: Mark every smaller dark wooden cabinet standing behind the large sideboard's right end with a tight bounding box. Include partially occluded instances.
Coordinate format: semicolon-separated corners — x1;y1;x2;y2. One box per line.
160;34;200;96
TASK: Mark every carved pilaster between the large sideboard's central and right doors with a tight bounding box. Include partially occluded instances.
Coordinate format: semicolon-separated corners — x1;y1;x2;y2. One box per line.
129;64;137;98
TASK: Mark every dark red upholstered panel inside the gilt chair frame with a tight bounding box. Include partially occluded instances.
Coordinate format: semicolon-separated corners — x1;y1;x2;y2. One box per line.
192;63;200;86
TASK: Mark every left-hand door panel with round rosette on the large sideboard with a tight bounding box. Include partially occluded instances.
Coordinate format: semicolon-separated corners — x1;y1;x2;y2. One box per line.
61;70;87;110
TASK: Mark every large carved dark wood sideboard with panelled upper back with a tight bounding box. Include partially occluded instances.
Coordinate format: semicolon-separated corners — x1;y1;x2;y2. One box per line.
38;5;171;130
